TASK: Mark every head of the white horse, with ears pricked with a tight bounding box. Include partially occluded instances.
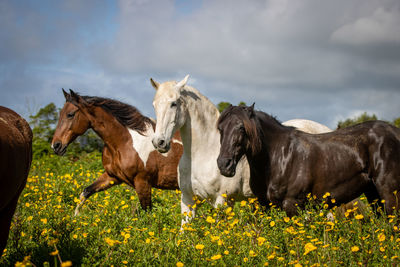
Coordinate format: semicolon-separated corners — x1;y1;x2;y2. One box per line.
150;75;189;153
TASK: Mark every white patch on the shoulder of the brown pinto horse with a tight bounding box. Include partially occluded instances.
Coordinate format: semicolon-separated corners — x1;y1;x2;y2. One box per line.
128;125;155;167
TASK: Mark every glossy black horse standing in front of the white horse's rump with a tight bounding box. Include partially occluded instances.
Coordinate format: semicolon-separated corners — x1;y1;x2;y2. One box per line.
218;105;400;216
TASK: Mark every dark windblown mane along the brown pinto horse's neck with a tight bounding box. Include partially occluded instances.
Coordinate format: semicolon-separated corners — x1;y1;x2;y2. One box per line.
69;96;154;134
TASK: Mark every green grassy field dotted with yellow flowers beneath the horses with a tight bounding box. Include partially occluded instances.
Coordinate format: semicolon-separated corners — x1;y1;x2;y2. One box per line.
0;153;400;266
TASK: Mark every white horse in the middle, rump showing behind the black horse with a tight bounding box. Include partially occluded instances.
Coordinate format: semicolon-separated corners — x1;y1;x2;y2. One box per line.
150;75;330;224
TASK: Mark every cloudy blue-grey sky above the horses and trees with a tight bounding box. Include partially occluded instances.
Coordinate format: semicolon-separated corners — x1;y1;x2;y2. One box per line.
0;0;400;128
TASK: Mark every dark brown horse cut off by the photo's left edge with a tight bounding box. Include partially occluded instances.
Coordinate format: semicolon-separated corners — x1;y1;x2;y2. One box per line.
0;106;32;253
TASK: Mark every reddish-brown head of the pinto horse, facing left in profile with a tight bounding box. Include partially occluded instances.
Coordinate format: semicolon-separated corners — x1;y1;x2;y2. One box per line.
51;89;90;156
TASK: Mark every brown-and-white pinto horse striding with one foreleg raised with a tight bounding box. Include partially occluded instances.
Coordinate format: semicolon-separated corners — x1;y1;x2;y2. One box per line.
52;90;183;214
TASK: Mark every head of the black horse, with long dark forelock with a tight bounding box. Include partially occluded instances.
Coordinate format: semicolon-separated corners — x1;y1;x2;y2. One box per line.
217;104;255;177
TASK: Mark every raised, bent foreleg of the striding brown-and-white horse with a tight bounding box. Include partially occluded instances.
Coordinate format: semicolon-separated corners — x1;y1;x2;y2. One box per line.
75;172;121;216
